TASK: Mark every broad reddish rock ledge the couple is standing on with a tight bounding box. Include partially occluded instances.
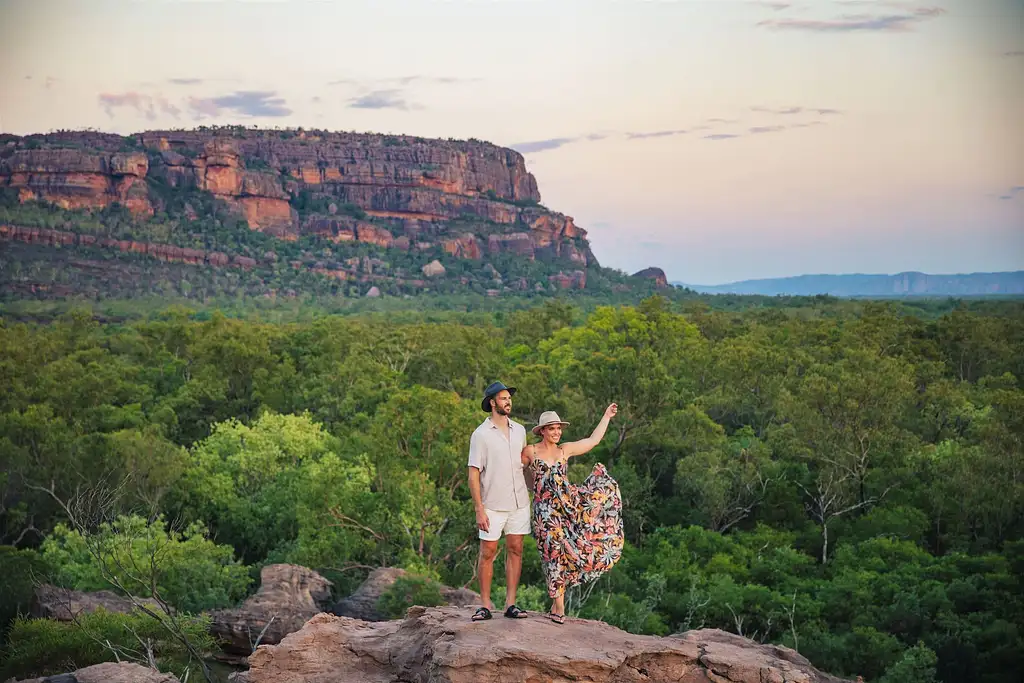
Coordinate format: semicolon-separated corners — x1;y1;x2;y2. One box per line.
245;607;842;683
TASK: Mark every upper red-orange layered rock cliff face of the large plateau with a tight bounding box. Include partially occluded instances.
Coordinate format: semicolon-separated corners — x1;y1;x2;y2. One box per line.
0;129;597;270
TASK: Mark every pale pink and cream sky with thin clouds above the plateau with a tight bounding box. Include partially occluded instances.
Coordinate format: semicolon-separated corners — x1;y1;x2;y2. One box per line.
0;0;1024;285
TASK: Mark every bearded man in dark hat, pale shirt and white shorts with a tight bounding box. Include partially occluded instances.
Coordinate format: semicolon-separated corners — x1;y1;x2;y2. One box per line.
469;382;529;622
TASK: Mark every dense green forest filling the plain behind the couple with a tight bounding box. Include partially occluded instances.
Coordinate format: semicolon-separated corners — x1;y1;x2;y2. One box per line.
0;297;1024;683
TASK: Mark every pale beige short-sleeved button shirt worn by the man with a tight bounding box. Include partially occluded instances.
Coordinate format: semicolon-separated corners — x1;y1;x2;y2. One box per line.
469;418;529;512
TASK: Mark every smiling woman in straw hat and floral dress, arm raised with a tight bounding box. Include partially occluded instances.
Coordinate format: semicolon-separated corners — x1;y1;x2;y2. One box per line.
521;403;624;624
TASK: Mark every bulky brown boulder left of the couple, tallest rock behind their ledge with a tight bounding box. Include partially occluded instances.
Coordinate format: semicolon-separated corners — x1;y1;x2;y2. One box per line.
210;564;331;654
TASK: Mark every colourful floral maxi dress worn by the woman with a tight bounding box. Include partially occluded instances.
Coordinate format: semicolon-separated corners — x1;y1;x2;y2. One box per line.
532;458;625;598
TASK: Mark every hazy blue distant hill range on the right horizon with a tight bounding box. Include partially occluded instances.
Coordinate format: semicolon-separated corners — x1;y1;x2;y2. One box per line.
672;270;1024;297
